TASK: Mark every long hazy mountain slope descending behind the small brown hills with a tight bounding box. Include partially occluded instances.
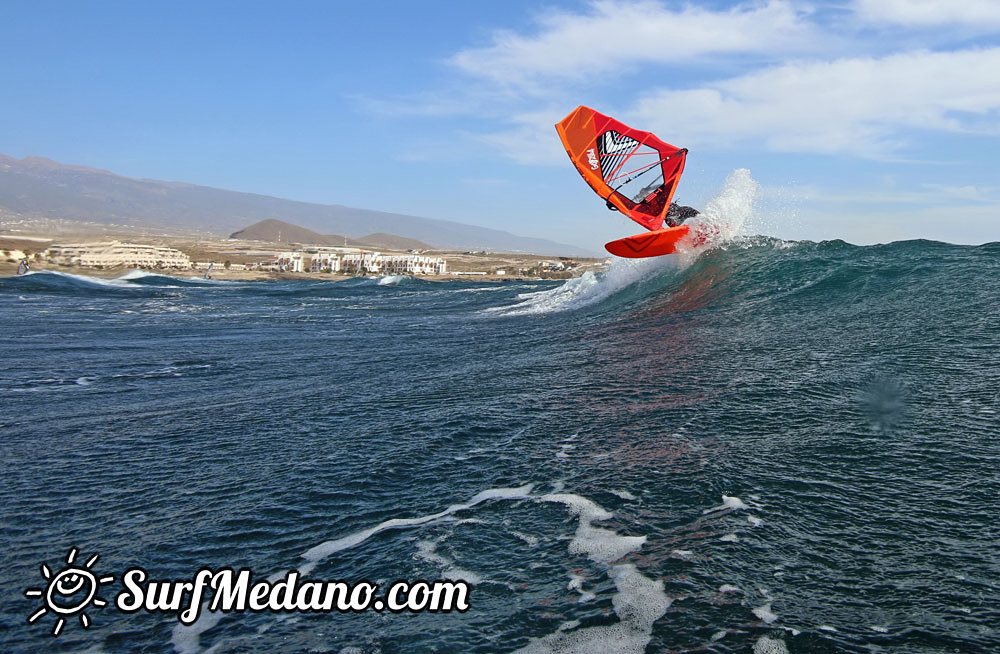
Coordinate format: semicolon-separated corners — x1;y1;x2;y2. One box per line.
0;155;593;256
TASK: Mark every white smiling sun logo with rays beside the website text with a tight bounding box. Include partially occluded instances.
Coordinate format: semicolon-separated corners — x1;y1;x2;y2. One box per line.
24;547;115;636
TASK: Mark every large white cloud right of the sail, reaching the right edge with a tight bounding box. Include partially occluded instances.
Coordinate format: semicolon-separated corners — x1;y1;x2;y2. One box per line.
630;48;1000;157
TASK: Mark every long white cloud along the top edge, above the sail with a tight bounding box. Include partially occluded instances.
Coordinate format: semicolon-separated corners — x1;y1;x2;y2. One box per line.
452;0;820;86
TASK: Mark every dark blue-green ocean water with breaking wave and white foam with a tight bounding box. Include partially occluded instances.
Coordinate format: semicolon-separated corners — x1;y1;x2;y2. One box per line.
0;175;1000;654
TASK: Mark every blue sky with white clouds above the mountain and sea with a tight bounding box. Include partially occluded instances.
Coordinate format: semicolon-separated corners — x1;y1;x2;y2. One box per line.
0;0;1000;251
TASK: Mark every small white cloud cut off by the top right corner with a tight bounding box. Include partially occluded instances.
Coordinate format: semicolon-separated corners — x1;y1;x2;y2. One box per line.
854;0;1000;29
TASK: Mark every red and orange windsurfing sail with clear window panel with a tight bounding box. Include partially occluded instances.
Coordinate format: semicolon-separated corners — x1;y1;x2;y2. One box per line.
556;106;687;230
